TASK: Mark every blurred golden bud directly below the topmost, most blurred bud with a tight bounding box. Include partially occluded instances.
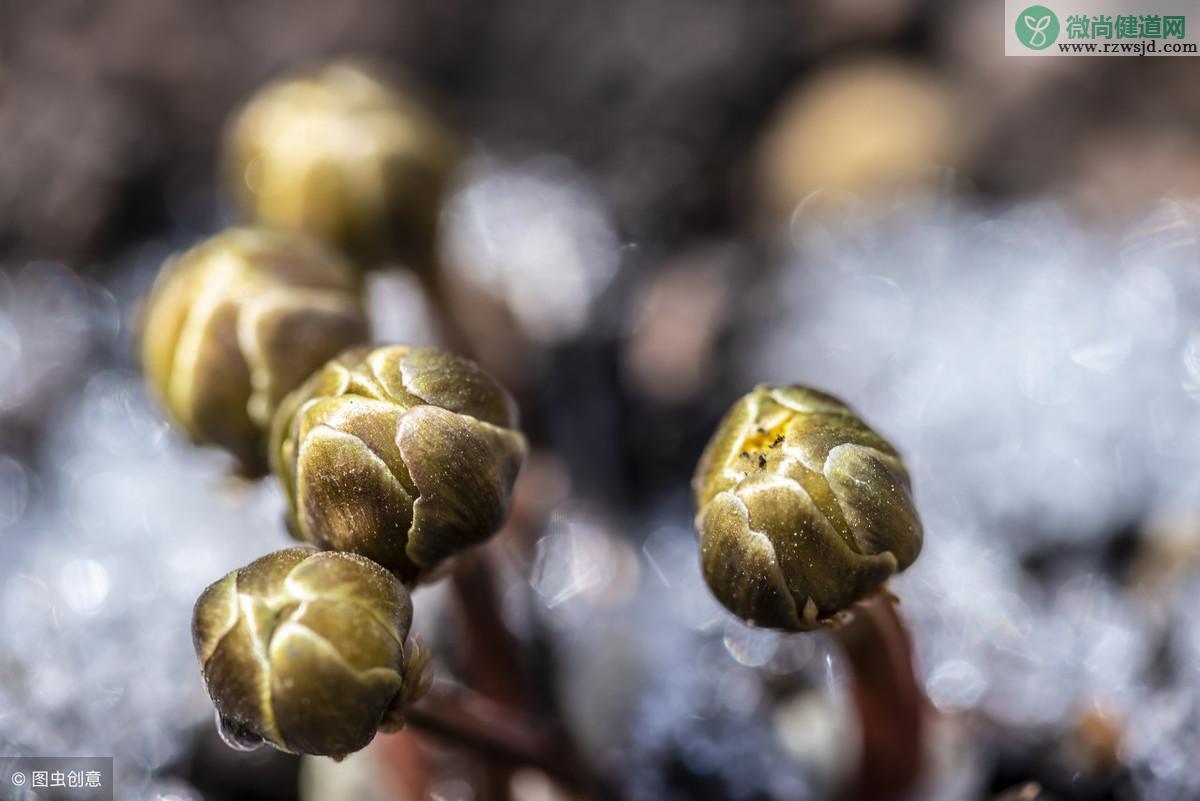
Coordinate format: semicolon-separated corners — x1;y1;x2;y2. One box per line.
142;228;368;474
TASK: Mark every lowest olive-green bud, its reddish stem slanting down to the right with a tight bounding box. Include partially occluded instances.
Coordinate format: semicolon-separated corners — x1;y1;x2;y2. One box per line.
192;548;428;757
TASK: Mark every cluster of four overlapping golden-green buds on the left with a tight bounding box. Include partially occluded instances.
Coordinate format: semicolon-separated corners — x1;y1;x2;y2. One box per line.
142;65;526;757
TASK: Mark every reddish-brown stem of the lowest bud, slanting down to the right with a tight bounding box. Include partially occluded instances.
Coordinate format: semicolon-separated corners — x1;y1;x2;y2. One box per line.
404;691;588;791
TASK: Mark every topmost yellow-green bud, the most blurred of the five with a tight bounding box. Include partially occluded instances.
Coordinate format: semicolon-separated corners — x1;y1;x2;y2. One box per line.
226;64;460;270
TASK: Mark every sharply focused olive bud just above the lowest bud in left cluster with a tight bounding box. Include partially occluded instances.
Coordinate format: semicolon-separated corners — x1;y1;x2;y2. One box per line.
270;345;526;580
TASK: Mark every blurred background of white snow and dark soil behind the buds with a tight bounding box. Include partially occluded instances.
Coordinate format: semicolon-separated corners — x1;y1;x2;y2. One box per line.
0;0;1200;801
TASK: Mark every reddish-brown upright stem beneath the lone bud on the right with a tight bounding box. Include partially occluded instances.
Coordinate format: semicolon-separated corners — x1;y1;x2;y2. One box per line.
835;590;925;801
